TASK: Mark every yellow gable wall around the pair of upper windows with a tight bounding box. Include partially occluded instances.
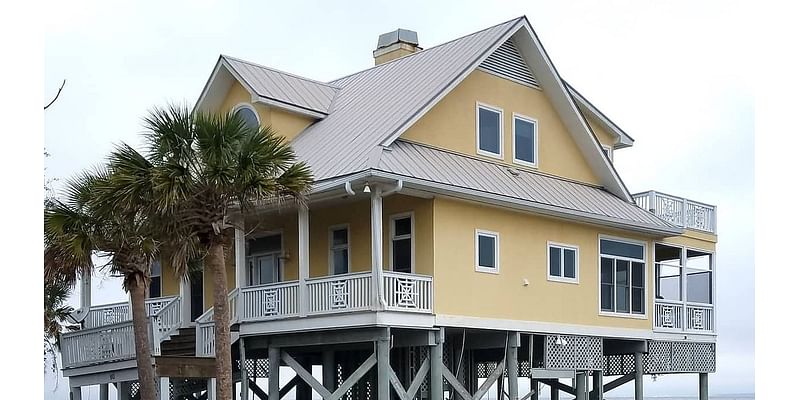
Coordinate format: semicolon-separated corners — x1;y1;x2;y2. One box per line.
401;70;600;184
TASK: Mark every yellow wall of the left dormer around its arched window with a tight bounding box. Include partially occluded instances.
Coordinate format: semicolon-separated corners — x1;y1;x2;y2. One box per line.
218;82;314;141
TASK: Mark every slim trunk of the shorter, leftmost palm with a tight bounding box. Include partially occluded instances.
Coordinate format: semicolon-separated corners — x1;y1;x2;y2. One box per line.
128;279;156;400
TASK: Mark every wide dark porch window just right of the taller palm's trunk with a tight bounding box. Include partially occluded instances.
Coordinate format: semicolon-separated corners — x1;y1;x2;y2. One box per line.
247;233;283;285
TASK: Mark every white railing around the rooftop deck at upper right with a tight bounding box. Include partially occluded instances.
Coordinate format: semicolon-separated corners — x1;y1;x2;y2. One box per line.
633;190;717;233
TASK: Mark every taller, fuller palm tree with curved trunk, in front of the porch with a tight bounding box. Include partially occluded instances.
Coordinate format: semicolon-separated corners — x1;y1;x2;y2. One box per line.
128;106;313;400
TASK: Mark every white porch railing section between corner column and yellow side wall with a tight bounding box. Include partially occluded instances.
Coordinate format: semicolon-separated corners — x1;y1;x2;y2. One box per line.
383;272;433;312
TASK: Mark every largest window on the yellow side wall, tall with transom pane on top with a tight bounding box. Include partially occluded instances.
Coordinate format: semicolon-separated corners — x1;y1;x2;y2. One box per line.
600;239;645;315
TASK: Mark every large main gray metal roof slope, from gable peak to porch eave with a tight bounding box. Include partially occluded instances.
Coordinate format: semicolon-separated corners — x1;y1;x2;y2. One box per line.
292;18;521;180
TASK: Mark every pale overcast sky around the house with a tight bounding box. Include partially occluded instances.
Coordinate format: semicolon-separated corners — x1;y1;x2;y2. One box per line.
43;0;754;398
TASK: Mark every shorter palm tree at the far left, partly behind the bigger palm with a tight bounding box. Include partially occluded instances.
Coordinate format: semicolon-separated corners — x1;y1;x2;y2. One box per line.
44;170;162;400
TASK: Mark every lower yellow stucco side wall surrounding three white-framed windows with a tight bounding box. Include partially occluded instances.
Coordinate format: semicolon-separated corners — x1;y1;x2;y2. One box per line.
434;198;653;329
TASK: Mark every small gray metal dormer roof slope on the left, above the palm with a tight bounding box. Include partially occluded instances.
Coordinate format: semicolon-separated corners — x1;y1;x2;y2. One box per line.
222;56;338;114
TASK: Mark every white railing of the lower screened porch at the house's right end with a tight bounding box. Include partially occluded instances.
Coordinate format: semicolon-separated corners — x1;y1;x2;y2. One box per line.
653;300;714;333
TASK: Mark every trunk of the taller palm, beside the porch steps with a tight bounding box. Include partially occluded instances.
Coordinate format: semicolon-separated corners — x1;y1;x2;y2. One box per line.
205;243;233;400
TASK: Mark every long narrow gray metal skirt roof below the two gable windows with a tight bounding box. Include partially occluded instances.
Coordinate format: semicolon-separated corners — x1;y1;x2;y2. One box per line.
375;140;676;229
